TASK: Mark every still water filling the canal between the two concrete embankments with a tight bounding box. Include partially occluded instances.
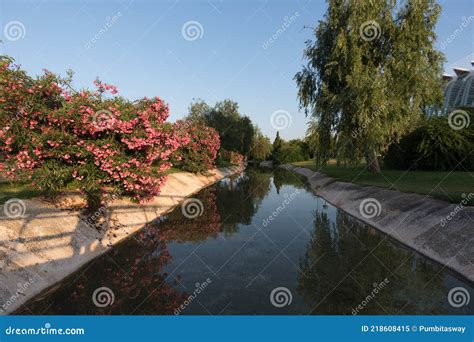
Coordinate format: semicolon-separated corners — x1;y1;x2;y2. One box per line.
17;168;474;315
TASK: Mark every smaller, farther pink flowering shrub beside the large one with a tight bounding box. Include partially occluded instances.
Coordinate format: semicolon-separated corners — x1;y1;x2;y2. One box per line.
174;121;220;172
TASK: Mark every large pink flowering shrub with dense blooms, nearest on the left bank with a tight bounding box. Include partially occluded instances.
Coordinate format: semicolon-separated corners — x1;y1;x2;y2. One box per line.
0;57;181;206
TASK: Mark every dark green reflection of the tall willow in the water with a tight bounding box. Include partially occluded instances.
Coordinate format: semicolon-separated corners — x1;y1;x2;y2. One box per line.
297;211;446;315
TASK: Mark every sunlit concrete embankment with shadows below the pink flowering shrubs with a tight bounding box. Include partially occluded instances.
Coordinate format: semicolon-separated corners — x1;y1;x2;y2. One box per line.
0;167;242;314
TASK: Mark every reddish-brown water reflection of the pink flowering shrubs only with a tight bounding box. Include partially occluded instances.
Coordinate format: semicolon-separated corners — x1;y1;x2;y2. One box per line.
19;188;220;315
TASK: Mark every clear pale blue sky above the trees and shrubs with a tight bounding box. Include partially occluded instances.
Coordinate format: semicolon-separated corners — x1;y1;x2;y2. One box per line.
0;0;474;139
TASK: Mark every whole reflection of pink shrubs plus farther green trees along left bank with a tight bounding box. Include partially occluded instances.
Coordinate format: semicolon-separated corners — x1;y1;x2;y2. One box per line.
19;170;271;315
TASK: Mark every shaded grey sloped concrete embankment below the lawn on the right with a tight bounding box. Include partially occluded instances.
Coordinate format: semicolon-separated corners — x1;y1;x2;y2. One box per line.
283;164;474;282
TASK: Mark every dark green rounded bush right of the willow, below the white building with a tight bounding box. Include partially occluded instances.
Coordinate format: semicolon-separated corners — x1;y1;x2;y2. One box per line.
384;115;474;171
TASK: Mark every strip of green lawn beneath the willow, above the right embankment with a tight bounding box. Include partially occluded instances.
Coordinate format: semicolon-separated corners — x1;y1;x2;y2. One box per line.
292;160;474;206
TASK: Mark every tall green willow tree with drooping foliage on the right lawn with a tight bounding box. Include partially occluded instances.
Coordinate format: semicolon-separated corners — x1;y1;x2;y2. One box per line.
295;0;443;172
